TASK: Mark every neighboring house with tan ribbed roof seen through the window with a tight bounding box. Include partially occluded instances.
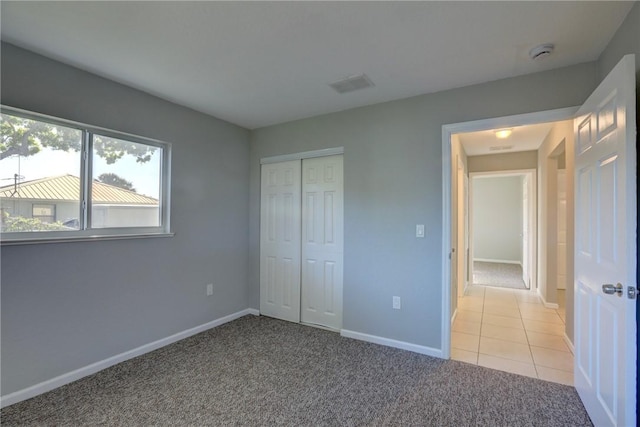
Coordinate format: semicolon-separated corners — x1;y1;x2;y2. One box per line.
0;175;159;228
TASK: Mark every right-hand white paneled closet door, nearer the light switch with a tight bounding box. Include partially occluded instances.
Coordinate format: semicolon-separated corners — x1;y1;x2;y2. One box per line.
302;155;344;329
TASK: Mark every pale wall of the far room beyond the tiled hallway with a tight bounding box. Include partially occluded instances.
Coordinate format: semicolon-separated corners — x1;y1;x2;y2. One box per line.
471;176;523;263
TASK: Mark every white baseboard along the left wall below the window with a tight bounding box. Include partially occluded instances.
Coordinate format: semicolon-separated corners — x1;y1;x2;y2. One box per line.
0;308;260;408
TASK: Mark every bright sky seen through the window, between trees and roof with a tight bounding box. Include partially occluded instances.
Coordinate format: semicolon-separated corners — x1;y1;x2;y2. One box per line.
0;148;161;199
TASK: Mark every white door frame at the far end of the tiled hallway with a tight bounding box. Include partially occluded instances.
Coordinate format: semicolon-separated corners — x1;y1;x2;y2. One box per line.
468;169;538;294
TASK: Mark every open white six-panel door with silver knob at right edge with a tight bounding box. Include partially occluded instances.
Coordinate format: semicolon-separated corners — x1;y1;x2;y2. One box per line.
574;55;637;426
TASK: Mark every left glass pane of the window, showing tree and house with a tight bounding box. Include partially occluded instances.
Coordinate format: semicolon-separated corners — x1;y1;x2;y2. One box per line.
0;112;83;234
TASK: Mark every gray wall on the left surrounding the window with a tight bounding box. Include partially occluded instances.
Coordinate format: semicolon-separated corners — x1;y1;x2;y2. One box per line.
0;44;250;395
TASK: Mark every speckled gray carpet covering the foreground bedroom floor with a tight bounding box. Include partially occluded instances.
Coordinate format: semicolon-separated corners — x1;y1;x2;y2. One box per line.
1;316;591;426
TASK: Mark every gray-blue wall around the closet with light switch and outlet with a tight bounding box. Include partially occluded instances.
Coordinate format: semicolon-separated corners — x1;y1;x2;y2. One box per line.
250;63;597;348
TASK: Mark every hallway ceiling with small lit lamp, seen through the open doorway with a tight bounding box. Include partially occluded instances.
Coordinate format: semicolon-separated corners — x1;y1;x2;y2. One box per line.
457;123;553;156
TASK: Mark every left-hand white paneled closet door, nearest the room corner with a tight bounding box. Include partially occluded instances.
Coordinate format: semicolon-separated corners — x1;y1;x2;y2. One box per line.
260;160;301;322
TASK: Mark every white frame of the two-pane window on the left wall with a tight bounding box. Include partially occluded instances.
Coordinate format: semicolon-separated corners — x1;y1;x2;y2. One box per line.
0;105;173;246
